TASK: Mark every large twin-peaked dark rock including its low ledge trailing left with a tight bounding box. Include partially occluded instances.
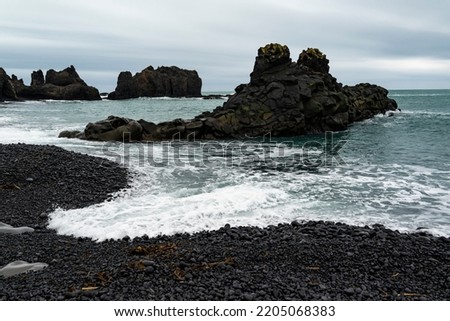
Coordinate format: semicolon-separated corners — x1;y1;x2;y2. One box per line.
60;44;397;141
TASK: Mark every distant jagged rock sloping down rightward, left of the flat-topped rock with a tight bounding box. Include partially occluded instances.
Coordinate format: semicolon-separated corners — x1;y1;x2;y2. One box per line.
13;66;101;100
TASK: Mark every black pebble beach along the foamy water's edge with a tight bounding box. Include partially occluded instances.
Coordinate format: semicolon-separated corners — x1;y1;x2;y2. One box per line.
0;144;450;300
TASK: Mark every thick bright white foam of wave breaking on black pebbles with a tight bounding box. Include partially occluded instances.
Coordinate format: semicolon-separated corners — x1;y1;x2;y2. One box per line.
49;180;288;240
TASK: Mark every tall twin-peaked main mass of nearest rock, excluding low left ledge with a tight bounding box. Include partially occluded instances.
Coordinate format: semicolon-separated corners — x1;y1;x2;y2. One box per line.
206;44;397;137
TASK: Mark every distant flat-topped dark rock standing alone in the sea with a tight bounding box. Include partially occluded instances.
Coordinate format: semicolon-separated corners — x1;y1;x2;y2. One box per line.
108;66;202;99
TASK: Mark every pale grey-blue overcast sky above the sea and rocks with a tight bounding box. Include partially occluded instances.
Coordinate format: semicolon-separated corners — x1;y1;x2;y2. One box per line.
0;0;450;91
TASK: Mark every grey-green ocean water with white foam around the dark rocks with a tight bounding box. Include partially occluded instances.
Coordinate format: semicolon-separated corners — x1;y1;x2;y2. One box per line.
0;90;450;240
